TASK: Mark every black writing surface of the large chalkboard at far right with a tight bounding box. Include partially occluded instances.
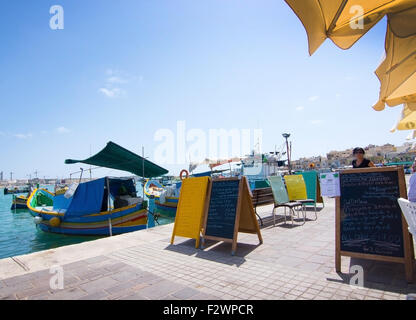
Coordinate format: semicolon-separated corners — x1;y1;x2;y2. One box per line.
340;171;404;257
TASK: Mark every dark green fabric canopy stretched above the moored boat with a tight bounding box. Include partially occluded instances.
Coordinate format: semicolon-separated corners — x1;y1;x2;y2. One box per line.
65;141;169;178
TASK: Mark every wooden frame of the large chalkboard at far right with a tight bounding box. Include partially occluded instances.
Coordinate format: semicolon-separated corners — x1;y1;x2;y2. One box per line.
335;167;415;282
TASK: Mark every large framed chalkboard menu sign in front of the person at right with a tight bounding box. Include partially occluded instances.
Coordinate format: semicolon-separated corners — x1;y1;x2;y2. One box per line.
335;167;414;282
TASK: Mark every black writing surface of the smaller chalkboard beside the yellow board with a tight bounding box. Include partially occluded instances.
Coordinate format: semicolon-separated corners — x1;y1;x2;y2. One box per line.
205;180;240;239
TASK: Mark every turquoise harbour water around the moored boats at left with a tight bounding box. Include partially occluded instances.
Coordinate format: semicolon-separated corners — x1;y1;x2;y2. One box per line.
0;186;174;259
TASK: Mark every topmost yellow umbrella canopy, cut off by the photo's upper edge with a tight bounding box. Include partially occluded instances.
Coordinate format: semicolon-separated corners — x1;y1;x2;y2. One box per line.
285;0;416;55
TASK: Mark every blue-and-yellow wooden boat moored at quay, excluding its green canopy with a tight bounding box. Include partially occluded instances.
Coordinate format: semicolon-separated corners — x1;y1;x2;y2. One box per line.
27;177;154;235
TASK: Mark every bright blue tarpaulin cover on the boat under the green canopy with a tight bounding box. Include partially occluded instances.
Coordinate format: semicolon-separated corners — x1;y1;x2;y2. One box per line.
65;178;106;217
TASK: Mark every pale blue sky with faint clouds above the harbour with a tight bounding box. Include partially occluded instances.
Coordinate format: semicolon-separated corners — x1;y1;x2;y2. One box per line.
0;0;408;178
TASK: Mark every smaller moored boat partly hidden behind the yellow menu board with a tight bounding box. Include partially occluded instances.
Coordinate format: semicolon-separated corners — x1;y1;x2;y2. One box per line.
144;179;180;218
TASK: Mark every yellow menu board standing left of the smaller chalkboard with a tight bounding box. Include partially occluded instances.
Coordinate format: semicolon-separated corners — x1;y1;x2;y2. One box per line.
171;177;210;248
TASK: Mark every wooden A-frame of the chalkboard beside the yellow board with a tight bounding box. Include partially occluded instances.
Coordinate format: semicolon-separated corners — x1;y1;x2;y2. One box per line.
201;176;263;255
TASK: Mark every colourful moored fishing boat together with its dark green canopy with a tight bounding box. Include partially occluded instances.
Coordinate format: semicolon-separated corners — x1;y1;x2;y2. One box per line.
27;142;168;235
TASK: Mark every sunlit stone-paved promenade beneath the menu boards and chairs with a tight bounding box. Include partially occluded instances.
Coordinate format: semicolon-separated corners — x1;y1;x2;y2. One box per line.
0;199;416;300
